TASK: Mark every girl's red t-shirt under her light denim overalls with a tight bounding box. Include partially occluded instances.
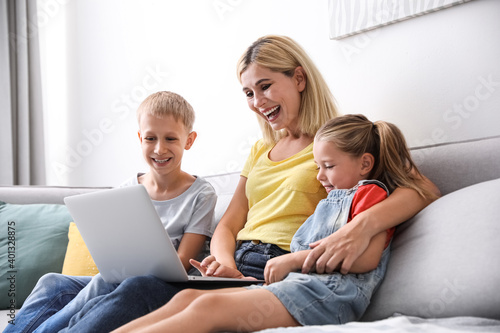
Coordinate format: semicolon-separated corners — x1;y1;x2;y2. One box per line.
347;184;396;248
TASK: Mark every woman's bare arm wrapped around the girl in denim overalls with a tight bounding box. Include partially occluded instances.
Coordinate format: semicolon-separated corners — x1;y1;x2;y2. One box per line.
302;179;439;274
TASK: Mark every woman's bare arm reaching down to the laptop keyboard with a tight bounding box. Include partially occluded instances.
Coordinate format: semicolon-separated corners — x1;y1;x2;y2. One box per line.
202;176;248;276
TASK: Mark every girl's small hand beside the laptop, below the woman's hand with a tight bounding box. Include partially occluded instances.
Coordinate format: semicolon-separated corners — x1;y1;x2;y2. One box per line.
264;251;307;284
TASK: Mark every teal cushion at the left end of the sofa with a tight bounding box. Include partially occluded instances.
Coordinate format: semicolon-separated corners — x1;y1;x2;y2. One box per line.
0;201;72;309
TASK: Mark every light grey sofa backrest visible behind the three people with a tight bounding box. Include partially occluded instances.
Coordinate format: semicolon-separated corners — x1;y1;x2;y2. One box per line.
0;136;500;221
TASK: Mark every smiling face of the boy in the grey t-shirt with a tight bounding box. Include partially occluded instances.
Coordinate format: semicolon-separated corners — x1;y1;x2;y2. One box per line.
139;114;196;175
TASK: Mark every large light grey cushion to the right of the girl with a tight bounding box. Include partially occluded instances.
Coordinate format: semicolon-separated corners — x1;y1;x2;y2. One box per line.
363;179;500;321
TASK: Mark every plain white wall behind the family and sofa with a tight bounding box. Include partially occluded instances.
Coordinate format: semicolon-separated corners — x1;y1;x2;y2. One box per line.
39;0;500;186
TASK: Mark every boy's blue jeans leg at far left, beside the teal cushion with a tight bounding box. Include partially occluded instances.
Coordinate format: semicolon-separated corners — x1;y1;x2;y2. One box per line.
4;273;91;333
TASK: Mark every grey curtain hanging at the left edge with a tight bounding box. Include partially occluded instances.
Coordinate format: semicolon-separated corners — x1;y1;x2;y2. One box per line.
0;0;45;185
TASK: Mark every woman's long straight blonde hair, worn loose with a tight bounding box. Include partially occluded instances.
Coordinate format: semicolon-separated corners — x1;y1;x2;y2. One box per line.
237;35;337;144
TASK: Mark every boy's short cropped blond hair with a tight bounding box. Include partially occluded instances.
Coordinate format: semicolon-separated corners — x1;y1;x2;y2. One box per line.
137;91;195;133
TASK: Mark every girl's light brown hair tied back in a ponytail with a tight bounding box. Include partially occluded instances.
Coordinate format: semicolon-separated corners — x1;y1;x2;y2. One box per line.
315;115;436;199
